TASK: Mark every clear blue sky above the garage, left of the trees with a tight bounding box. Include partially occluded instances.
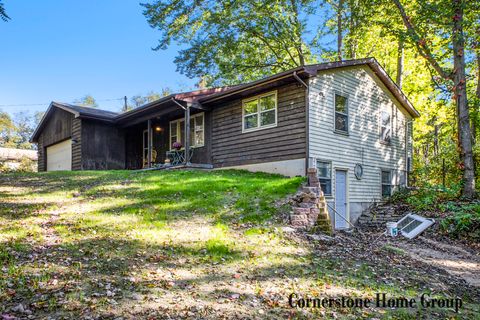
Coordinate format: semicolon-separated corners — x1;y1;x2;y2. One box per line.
0;0;196;114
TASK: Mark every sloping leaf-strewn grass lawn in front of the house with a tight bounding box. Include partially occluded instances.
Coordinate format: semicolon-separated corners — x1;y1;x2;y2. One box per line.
0;170;480;319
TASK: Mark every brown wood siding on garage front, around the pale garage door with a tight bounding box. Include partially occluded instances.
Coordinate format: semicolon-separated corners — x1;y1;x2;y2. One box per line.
38;108;74;171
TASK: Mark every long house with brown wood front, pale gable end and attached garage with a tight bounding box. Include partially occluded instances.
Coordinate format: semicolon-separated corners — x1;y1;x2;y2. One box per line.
32;58;419;228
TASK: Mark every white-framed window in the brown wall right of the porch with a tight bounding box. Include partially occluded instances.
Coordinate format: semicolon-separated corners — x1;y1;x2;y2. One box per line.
242;91;277;132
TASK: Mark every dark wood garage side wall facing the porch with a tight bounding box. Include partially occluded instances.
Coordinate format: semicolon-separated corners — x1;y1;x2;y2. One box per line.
81;119;125;170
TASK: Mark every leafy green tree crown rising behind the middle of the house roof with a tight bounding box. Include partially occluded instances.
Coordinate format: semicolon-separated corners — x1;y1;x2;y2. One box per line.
142;0;315;85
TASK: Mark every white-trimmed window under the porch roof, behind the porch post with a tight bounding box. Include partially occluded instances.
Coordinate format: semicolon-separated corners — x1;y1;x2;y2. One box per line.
170;112;205;150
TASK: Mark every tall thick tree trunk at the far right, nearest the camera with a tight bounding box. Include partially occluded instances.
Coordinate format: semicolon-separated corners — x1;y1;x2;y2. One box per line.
452;0;475;198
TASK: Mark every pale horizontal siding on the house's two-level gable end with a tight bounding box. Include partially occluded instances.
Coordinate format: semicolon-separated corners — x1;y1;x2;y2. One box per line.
309;67;409;202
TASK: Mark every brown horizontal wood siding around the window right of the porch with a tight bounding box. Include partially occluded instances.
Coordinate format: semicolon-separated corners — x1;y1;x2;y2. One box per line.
211;84;306;167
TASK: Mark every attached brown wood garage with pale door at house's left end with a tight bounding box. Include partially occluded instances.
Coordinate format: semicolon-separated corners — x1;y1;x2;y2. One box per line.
31;102;120;171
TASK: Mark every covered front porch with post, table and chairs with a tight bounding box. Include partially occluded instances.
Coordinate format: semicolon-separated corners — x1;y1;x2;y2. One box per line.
116;97;213;170
